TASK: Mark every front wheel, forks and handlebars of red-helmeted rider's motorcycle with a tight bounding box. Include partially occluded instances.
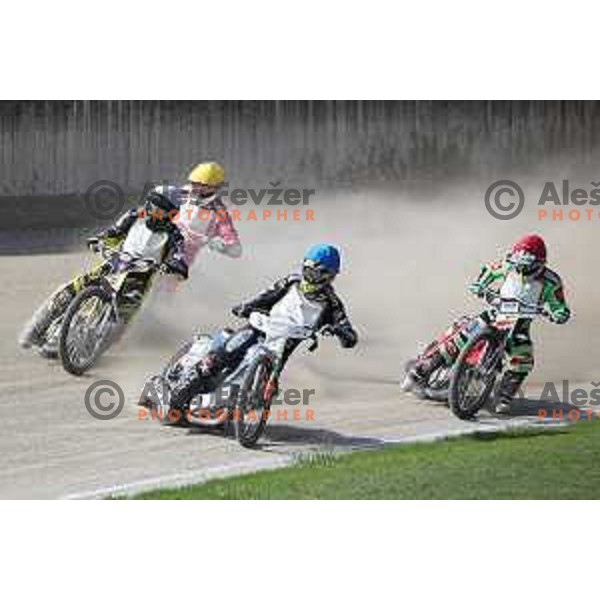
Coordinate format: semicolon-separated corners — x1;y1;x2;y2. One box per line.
448;292;549;419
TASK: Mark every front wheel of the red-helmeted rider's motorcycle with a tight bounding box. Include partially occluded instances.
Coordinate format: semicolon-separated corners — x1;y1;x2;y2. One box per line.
448;330;504;420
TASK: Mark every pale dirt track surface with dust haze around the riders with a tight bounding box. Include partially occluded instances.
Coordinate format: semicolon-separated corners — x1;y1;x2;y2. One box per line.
0;187;600;498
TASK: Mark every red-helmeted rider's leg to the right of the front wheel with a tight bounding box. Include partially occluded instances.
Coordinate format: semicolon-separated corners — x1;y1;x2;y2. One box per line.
496;324;534;414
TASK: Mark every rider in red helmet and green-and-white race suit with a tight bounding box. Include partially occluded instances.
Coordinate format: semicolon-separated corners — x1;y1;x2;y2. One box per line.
407;234;570;414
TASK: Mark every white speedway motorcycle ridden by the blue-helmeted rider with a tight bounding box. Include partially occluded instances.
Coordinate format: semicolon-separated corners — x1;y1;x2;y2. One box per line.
139;312;331;448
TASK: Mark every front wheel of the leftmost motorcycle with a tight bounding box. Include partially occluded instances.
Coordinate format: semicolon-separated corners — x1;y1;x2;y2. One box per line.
58;286;114;375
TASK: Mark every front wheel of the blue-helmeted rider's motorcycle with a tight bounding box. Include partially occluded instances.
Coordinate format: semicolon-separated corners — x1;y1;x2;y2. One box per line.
233;356;273;448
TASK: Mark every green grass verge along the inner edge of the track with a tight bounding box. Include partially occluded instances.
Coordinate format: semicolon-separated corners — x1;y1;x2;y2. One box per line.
137;422;600;499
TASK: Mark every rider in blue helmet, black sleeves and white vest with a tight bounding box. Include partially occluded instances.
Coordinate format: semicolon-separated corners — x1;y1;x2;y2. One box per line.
198;244;358;375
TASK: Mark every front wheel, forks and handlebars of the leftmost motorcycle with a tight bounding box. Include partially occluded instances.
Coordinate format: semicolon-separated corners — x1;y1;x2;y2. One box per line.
58;242;161;375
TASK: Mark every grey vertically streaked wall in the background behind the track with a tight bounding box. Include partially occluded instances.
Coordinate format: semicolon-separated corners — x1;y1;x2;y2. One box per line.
0;101;600;197
